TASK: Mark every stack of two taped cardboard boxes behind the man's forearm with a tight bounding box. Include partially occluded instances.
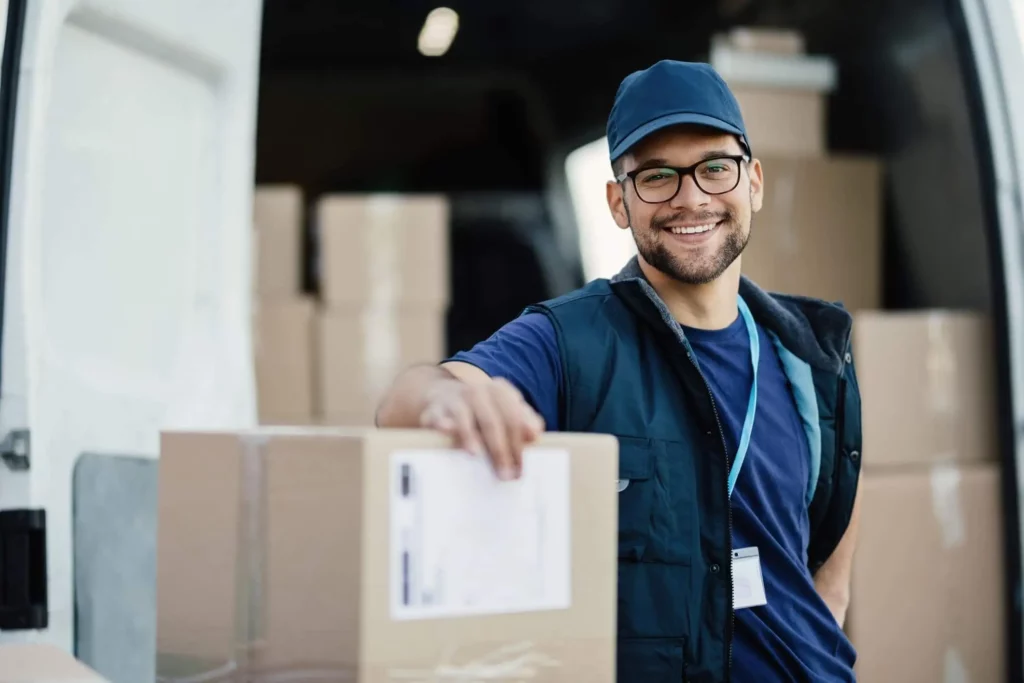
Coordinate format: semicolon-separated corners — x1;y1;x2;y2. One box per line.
316;195;449;426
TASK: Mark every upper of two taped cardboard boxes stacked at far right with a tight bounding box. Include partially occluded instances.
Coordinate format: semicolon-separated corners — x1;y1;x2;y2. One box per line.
853;310;997;467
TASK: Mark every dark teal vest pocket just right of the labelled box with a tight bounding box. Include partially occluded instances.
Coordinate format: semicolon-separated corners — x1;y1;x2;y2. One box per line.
617;436;654;561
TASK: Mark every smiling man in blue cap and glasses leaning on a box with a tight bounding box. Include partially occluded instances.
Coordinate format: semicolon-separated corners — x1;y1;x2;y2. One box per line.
378;61;860;683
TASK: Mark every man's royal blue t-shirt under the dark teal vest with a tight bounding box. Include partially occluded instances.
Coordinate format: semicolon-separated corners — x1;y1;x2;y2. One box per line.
452;313;855;683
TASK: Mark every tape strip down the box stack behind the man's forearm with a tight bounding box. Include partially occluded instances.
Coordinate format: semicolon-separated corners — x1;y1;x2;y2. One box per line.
361;195;402;402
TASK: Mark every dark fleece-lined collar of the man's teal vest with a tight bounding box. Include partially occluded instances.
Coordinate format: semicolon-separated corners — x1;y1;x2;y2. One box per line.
611;256;853;374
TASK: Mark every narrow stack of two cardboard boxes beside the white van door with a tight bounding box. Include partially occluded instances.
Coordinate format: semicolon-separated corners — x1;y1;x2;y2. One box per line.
253;185;315;425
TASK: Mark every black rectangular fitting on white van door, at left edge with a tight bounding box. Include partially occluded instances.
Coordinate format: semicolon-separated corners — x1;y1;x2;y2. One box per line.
0;510;49;631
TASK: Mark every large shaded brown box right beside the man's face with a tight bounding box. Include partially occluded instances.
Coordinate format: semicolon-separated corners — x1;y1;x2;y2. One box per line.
742;156;882;311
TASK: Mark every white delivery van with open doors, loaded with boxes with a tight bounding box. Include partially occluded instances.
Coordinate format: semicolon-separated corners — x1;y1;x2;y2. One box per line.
0;0;1024;683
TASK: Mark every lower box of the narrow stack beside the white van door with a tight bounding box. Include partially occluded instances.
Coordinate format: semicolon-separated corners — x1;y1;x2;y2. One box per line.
253;298;316;425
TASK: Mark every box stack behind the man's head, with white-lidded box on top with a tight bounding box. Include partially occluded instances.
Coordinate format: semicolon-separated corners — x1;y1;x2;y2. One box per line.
710;29;882;310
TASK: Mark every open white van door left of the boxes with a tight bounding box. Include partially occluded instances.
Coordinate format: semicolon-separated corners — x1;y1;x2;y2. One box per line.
0;0;261;650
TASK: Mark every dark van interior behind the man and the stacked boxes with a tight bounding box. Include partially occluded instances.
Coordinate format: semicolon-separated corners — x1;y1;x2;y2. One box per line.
256;0;1022;667
